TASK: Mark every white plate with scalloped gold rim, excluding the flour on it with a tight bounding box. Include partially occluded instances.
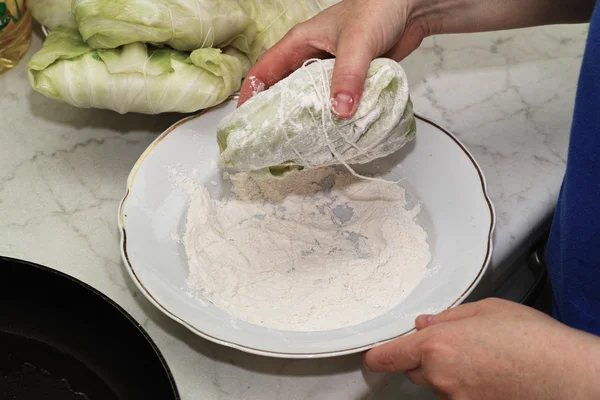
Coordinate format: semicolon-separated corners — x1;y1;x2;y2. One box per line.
119;99;495;358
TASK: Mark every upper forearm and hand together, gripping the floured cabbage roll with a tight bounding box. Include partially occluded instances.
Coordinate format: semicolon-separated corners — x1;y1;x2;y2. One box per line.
239;0;595;118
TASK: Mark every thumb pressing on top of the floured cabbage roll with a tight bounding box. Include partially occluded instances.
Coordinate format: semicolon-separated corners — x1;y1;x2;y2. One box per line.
331;29;376;119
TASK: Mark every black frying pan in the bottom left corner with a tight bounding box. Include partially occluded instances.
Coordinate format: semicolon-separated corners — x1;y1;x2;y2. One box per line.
0;257;179;400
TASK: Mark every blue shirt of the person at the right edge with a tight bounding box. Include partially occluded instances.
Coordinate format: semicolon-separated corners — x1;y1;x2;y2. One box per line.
546;2;600;335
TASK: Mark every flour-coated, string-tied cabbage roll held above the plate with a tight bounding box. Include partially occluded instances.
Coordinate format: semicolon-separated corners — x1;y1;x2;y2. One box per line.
217;58;416;171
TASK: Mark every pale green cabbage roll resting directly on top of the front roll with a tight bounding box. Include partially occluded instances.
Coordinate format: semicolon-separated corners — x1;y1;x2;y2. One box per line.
72;0;250;51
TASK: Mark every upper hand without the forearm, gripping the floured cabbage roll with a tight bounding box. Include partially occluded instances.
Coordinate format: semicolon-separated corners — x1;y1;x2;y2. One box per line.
238;0;434;118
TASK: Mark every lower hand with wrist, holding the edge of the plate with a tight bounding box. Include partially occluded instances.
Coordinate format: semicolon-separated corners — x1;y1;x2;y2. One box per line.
364;299;600;400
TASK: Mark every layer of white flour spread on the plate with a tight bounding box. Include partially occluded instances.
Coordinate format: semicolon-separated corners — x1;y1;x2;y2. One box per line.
183;168;431;331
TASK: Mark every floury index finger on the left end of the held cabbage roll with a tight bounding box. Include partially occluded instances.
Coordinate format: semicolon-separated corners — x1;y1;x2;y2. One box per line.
238;25;329;107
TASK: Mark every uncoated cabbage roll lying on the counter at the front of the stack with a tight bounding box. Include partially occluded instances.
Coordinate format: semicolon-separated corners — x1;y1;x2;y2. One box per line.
28;28;242;114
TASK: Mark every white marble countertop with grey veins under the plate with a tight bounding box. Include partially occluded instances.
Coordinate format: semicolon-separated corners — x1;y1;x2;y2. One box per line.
0;25;587;400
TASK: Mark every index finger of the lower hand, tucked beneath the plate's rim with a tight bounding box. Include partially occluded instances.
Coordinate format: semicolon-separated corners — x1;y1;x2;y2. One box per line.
363;332;427;372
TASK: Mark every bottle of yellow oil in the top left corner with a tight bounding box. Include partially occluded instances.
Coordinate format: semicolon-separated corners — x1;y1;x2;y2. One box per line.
0;0;33;73
